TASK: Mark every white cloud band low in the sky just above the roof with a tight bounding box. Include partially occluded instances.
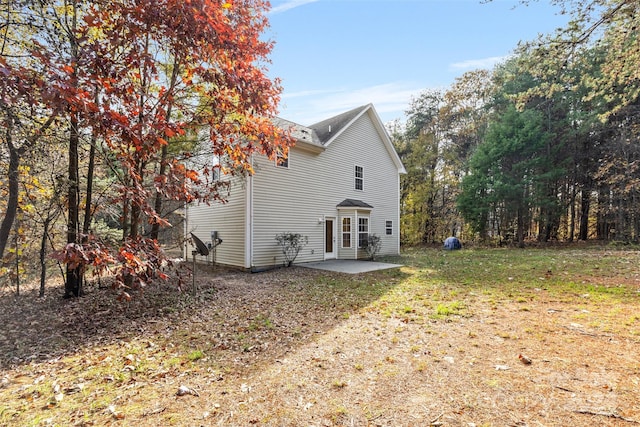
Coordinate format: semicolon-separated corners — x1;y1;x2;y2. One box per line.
280;82;424;126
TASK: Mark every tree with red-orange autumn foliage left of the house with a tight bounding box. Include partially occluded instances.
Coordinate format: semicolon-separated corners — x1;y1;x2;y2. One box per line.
0;0;290;294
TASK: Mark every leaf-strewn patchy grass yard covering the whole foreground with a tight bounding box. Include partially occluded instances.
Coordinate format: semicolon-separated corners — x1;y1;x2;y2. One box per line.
0;247;640;426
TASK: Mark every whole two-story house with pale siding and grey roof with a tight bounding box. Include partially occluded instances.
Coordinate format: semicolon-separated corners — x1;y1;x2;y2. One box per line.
185;104;406;271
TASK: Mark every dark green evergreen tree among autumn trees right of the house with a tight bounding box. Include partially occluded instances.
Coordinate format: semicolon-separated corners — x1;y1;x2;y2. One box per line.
458;105;548;247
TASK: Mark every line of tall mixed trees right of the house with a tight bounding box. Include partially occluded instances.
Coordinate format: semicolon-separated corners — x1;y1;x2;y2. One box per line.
391;0;640;246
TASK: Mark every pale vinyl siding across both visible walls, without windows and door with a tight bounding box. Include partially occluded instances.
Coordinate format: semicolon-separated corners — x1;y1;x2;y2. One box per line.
187;109;400;268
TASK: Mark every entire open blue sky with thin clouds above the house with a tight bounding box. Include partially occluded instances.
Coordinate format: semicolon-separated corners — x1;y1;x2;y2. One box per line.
264;0;568;126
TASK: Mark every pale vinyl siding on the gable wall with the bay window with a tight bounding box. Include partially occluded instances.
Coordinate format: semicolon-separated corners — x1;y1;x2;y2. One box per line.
253;113;400;266
